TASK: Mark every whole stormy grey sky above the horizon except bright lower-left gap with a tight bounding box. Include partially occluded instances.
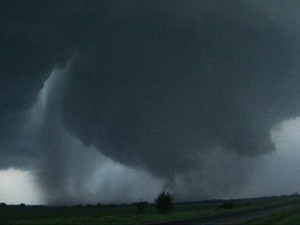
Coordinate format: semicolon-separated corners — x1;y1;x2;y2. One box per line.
0;0;300;204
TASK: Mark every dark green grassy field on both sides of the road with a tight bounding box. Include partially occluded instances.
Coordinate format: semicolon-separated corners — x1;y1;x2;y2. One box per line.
0;195;300;225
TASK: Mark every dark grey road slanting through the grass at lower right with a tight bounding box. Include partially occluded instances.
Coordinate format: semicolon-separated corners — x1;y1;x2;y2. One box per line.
152;203;300;225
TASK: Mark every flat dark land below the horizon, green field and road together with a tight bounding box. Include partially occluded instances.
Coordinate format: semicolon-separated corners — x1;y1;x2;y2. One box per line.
0;195;300;225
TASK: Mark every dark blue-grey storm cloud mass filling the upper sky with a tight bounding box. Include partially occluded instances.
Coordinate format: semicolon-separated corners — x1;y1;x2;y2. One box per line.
0;1;300;200
